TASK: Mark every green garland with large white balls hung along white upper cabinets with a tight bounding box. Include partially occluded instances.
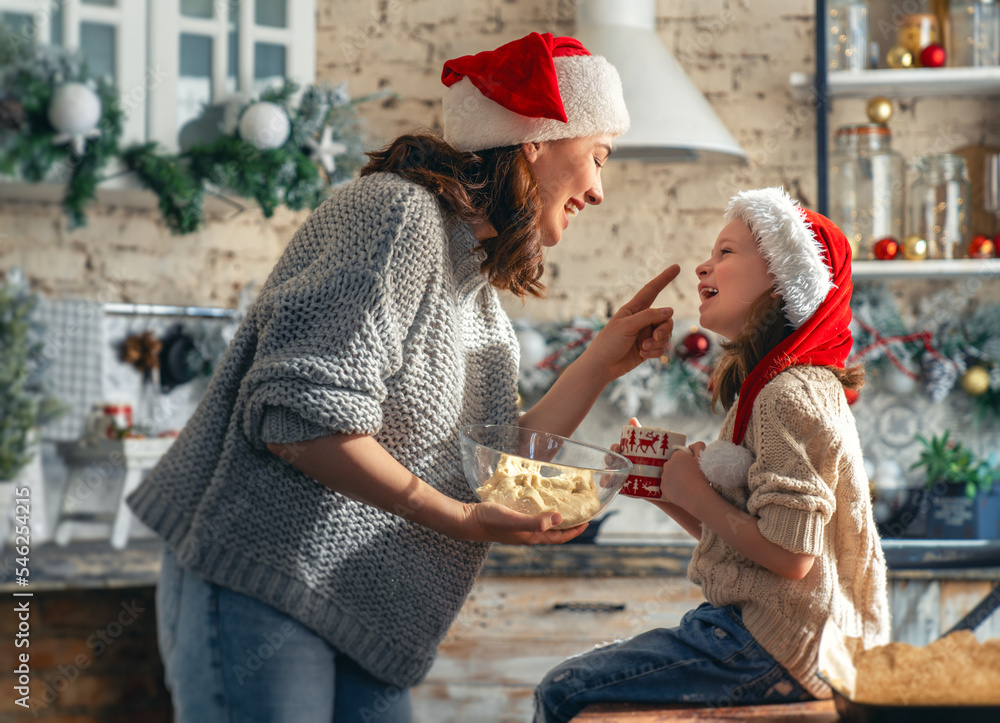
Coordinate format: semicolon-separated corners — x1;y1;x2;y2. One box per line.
0;38;388;234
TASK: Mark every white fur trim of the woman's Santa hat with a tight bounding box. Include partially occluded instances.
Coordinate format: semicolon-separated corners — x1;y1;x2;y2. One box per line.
443;55;629;151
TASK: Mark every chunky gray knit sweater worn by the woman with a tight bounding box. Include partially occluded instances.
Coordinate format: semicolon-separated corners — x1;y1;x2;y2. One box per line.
128;174;517;686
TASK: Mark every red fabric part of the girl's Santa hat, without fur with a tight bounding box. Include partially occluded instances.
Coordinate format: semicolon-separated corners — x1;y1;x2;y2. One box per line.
733;209;858;444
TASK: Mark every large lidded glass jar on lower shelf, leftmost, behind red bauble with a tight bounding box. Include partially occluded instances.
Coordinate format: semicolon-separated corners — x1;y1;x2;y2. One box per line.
830;123;906;259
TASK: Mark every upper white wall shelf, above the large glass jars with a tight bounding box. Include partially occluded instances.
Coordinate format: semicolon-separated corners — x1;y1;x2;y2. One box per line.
788;67;1000;98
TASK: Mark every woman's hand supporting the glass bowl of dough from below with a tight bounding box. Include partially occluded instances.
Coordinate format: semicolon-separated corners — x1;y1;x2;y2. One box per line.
457;502;587;545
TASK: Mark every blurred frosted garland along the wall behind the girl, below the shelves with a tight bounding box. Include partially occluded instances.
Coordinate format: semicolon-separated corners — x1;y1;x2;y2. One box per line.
515;284;1000;421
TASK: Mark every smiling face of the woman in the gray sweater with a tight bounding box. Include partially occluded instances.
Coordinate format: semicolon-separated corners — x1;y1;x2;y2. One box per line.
522;136;612;246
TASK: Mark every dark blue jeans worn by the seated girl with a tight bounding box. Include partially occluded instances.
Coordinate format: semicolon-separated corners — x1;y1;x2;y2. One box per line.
535;603;812;723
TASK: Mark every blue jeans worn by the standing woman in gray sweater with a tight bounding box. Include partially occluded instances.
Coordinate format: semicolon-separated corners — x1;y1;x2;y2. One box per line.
156;551;412;723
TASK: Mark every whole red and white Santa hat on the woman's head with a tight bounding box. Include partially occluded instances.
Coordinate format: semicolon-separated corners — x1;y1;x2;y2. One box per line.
441;33;629;151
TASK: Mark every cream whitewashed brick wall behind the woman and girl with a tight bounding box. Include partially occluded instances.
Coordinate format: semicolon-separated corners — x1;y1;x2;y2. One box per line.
0;0;1000;319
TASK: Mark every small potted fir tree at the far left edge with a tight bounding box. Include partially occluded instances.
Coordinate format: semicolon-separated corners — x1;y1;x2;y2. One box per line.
0;270;62;546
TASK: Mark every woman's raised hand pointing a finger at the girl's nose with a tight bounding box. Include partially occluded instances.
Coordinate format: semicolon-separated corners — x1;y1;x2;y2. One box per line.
583;264;681;382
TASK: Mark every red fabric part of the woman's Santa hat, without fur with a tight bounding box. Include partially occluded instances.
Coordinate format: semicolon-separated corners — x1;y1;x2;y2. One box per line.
441;33;590;123
